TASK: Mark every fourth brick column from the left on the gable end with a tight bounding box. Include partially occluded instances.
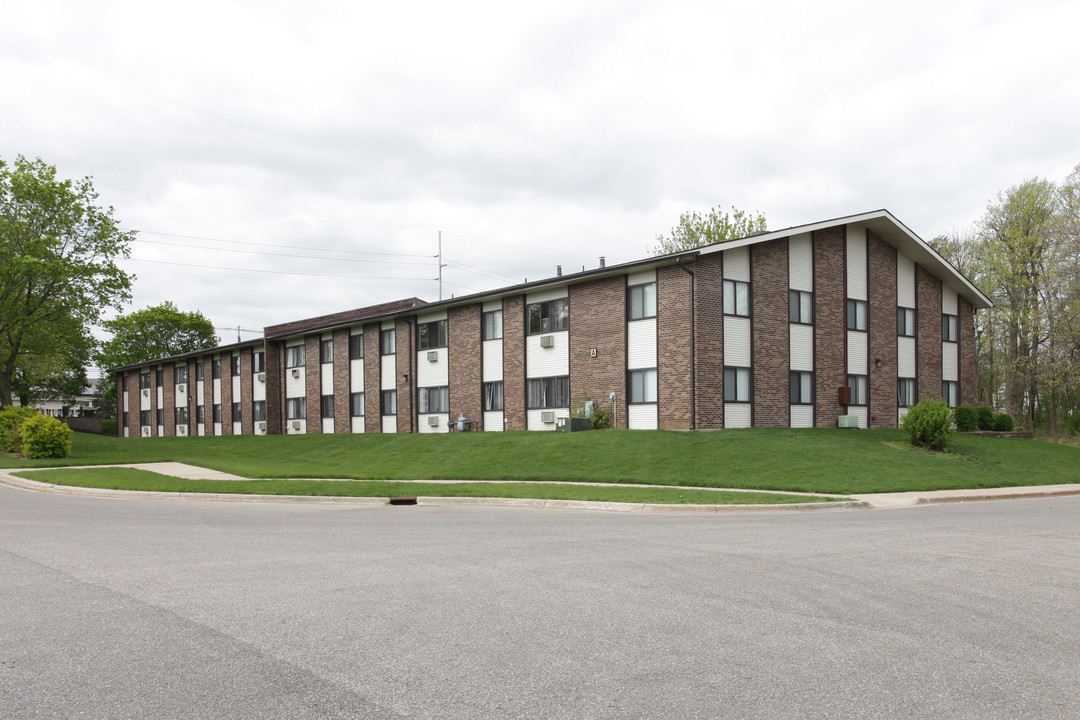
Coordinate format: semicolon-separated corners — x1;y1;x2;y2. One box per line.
867;233;897;427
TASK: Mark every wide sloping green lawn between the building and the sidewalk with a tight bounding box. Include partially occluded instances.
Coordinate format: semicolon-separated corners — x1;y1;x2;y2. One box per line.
0;429;1080;495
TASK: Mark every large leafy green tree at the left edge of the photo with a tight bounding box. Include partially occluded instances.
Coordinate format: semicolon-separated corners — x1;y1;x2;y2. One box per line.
0;155;134;406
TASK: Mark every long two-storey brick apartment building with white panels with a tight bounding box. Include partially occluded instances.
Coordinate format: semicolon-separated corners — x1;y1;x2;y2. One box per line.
113;210;990;437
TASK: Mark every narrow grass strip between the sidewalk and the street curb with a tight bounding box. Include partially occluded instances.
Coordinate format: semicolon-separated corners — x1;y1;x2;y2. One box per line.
16;467;846;505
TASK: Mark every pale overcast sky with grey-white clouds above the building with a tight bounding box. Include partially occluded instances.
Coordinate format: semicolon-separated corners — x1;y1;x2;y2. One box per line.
0;0;1080;342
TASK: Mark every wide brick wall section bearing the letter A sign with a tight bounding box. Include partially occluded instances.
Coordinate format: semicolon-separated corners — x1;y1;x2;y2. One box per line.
569;275;627;427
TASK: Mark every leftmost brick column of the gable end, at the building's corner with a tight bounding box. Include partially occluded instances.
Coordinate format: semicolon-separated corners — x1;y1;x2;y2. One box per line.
680;253;724;430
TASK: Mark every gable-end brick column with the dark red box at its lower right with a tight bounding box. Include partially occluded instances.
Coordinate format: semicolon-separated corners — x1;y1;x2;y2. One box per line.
813;227;848;427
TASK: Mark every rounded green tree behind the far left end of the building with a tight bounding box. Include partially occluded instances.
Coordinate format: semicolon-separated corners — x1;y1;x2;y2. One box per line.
97;301;218;400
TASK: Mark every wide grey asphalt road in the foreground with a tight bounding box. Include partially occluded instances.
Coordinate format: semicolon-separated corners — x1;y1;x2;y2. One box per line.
0;486;1080;720
